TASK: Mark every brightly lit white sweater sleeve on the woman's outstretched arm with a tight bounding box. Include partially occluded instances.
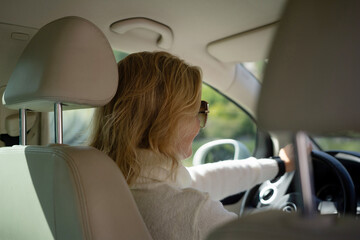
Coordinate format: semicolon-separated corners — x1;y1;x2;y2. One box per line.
187;157;279;200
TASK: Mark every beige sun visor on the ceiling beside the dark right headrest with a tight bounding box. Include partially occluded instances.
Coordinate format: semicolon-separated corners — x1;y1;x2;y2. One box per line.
207;23;277;63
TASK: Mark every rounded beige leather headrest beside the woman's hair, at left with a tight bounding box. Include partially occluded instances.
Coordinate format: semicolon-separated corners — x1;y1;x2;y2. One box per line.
3;17;118;112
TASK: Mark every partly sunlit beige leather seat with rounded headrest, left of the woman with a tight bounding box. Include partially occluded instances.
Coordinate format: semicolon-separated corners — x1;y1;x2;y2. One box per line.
0;17;151;240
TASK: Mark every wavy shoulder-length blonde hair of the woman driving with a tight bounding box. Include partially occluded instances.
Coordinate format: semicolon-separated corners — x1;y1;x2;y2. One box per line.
90;52;201;185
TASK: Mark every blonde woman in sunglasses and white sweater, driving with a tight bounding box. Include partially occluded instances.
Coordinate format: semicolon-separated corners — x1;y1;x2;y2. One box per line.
91;52;293;240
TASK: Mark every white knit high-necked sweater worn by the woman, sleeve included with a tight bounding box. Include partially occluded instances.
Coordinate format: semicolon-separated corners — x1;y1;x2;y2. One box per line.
131;150;278;240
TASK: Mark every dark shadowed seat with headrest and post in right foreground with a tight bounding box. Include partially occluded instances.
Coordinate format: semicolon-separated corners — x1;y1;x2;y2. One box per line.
208;0;360;240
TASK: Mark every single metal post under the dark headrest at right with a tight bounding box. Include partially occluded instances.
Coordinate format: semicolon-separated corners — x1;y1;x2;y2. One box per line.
295;132;316;217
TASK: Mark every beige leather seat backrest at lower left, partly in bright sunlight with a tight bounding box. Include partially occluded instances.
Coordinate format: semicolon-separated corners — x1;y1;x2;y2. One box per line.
0;145;150;239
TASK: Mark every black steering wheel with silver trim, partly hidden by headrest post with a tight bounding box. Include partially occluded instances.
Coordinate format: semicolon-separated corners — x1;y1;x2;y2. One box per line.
240;151;357;216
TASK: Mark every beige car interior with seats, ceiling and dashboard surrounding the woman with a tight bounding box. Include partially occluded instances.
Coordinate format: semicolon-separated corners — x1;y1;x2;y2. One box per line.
0;0;360;239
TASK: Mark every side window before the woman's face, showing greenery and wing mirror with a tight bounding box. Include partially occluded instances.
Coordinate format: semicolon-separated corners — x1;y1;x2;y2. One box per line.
183;84;257;166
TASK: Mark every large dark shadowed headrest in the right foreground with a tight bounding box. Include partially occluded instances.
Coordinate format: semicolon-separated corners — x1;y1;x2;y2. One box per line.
257;0;360;134
